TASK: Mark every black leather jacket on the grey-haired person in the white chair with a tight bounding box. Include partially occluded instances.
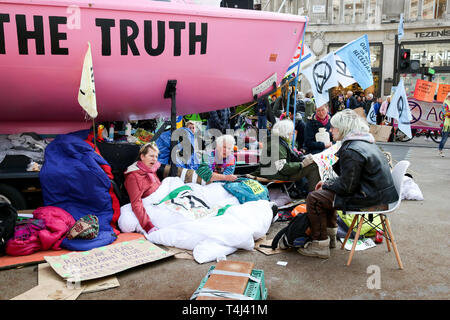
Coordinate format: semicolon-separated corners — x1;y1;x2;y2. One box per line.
322;140;399;210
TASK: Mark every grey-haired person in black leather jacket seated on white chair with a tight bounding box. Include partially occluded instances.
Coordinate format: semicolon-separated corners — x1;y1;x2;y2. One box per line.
298;109;398;259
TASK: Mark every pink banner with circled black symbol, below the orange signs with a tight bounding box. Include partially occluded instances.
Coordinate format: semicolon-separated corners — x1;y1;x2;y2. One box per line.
408;98;444;129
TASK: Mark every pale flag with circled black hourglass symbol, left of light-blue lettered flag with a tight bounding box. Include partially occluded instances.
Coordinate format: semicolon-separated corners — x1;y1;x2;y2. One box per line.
302;52;338;107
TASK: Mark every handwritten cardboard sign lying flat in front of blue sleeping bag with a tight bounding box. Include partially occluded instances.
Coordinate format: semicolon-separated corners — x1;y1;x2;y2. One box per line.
44;239;174;281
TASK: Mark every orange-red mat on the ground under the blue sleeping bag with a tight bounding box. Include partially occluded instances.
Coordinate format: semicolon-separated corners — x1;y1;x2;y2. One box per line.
0;233;144;270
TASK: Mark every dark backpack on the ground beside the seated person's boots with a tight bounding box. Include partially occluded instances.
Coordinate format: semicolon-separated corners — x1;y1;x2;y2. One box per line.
272;213;311;250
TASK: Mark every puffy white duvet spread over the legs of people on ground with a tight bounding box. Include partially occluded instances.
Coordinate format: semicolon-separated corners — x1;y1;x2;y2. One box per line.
118;177;272;263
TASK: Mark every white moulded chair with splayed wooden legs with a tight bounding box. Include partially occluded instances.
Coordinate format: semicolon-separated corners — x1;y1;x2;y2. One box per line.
341;160;410;269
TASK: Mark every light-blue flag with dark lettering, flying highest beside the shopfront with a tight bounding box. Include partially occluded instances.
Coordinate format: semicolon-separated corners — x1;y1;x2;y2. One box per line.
336;34;373;90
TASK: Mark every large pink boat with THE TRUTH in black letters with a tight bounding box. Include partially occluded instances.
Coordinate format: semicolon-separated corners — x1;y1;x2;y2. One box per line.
0;0;307;134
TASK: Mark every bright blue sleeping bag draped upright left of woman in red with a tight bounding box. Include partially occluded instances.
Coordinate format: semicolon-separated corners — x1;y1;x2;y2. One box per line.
39;130;117;251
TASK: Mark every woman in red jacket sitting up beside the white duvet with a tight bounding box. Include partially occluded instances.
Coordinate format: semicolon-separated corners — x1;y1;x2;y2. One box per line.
125;142;161;233
